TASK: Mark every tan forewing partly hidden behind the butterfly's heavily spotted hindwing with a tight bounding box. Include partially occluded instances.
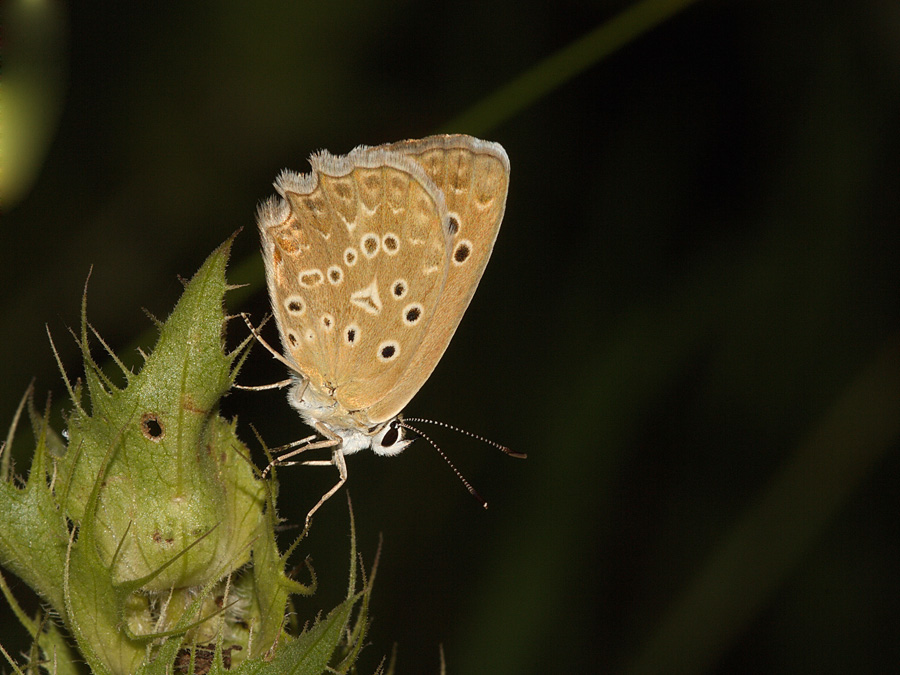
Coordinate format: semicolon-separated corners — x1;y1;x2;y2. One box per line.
367;135;509;421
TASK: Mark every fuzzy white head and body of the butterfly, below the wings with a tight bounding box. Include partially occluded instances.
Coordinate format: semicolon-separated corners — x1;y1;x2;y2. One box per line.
288;379;412;455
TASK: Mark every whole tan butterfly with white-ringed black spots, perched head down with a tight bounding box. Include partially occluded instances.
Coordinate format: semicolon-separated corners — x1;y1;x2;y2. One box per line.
251;135;516;523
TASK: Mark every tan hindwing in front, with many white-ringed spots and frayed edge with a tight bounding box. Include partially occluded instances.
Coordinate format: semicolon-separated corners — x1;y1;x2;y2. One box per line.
258;147;451;414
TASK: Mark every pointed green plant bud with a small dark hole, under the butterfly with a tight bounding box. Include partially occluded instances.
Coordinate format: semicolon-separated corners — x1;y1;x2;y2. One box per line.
57;236;264;591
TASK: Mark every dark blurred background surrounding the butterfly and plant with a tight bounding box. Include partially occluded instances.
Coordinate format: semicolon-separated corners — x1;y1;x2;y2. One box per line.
0;0;900;674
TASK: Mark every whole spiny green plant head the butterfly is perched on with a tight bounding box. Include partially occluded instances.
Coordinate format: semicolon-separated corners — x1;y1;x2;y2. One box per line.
0;240;370;673
